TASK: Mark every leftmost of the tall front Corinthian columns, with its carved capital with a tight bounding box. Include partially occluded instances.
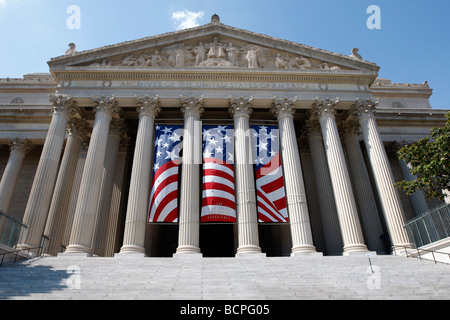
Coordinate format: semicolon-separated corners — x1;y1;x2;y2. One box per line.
18;95;80;248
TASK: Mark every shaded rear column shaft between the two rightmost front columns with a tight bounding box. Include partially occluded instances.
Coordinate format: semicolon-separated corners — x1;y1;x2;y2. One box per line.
343;124;385;252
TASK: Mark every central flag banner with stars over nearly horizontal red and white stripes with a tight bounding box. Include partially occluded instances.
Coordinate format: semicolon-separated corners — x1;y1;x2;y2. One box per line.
201;125;236;222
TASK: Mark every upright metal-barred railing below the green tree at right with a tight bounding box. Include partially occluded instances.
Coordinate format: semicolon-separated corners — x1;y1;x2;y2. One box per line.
405;204;450;248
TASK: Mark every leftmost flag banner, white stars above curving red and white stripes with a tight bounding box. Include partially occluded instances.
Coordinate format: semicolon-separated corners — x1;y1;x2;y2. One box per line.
149;125;182;222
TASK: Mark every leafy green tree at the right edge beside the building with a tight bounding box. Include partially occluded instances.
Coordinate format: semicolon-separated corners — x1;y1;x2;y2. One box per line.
396;112;450;200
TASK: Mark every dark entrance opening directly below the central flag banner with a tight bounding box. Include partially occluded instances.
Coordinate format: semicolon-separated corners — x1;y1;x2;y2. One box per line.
200;223;236;258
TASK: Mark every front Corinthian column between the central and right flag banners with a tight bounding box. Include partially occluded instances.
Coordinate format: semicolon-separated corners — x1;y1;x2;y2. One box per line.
229;97;261;254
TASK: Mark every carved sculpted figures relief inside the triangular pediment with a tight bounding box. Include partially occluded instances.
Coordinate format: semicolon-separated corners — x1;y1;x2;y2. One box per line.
90;37;341;70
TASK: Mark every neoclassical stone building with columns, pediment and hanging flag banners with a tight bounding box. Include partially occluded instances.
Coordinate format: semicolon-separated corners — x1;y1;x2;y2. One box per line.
0;16;447;257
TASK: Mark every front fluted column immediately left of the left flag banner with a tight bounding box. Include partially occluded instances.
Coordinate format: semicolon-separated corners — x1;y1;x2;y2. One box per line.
120;96;161;256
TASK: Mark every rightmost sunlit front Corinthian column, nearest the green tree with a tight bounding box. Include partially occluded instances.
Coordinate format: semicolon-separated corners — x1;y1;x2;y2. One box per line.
353;99;412;251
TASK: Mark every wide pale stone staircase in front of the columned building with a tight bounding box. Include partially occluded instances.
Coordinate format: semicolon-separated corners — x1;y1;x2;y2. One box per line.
0;255;450;300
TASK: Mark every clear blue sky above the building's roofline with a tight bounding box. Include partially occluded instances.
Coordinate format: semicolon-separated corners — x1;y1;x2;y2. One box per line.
0;0;450;109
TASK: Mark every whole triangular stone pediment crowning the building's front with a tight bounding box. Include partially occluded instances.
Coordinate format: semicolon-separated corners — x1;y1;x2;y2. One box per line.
49;19;379;72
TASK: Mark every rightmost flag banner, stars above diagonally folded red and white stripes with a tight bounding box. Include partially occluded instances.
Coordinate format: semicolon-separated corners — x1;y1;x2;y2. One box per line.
252;126;289;222
